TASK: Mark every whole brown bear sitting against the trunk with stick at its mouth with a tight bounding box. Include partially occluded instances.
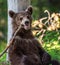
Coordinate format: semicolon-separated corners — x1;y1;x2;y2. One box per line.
9;7;57;65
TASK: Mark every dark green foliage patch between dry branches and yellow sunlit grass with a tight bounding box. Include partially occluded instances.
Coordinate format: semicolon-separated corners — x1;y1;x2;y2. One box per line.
43;30;60;42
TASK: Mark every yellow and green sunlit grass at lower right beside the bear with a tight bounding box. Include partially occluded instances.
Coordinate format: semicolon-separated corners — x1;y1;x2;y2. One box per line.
43;41;60;61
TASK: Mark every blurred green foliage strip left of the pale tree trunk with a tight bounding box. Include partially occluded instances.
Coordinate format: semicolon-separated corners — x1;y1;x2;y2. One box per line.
0;0;7;62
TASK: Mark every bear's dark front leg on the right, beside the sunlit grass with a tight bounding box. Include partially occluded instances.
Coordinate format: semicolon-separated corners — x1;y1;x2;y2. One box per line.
33;40;51;65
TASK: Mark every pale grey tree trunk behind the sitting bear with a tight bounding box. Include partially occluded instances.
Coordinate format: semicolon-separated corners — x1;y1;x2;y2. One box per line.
7;0;30;60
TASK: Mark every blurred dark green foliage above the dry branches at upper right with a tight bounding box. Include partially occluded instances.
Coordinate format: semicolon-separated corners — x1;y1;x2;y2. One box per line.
31;0;60;19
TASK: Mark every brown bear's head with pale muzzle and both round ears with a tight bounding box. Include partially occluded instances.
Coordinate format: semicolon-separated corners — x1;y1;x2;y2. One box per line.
9;6;32;32
